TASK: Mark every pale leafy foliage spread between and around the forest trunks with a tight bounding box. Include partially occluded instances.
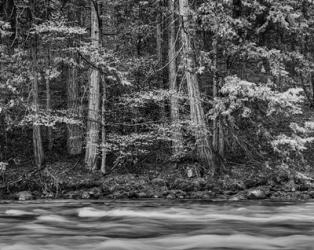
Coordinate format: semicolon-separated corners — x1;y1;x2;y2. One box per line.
0;0;314;175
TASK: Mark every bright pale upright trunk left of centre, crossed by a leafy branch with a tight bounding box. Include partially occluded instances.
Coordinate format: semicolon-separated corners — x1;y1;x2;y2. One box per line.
85;1;100;170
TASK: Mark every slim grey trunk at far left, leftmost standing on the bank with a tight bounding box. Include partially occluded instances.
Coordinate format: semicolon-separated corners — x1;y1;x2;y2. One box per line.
32;47;44;168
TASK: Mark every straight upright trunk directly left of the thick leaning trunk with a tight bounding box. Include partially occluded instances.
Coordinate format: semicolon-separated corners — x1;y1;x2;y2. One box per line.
168;0;183;155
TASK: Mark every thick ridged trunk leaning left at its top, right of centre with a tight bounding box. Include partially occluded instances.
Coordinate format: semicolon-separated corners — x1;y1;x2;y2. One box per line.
179;0;216;171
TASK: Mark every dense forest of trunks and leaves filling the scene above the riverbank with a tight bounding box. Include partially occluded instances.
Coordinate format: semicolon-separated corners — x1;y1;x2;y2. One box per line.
0;0;314;199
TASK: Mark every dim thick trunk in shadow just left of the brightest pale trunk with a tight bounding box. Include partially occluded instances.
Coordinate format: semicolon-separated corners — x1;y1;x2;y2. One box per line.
67;55;83;155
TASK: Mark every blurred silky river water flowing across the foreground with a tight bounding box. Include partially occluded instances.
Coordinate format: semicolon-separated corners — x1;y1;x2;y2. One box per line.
0;201;314;250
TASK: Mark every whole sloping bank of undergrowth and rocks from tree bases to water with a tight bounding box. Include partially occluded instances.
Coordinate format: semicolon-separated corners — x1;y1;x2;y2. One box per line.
0;160;314;201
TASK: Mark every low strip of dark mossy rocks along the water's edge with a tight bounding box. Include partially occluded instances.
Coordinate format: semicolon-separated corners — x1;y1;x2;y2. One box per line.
6;175;314;202
